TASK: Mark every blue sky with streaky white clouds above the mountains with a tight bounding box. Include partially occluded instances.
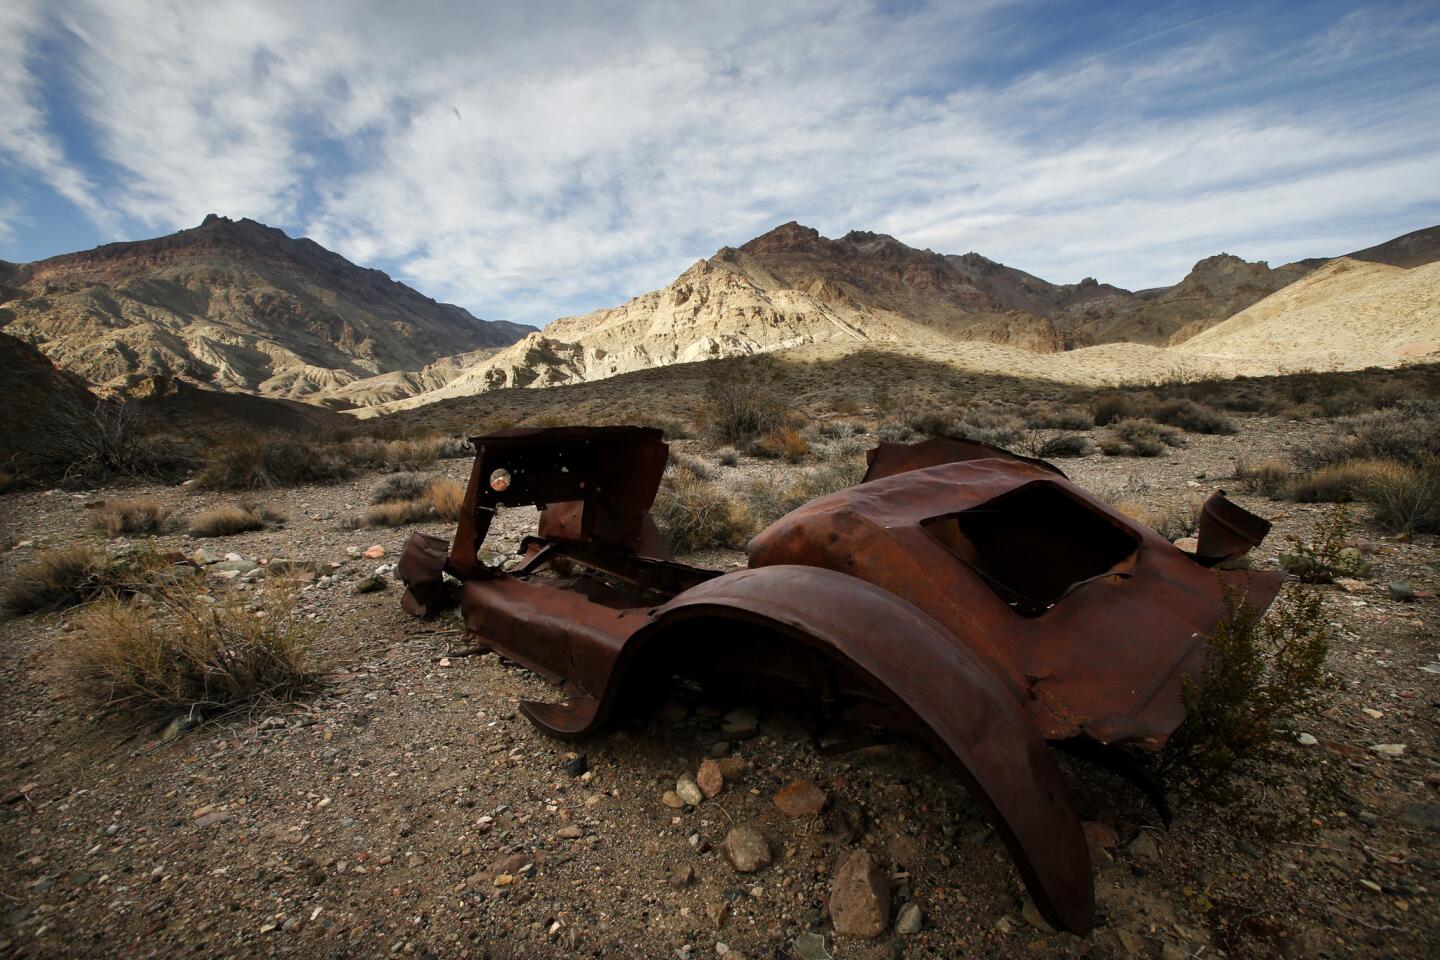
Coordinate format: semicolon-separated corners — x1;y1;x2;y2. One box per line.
0;0;1440;325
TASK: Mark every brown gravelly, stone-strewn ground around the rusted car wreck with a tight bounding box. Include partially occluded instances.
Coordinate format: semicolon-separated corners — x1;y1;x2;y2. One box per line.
0;417;1440;960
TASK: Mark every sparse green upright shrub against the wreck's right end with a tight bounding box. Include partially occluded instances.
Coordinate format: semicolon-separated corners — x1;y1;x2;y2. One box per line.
1161;589;1335;830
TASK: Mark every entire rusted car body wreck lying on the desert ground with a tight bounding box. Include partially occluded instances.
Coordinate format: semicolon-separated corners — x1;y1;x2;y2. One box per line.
397;427;1280;934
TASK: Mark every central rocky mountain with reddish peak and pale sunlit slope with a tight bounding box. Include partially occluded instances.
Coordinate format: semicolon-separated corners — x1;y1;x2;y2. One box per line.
368;223;1320;409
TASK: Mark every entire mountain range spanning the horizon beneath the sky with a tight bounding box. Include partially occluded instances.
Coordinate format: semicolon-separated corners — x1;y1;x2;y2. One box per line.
0;214;1440;413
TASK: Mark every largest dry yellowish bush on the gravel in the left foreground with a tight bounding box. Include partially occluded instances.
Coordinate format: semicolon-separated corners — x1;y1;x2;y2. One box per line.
62;581;317;717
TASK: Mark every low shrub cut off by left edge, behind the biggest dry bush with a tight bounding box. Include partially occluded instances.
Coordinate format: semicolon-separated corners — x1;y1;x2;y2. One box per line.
3;544;171;615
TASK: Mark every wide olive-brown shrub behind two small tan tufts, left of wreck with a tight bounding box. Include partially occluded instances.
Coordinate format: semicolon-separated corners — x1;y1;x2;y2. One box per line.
196;433;354;489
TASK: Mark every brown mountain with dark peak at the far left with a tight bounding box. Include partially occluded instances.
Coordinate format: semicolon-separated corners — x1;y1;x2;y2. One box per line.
0;214;531;399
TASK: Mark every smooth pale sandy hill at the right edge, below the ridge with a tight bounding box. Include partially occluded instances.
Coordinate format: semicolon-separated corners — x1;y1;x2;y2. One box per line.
1174;258;1440;370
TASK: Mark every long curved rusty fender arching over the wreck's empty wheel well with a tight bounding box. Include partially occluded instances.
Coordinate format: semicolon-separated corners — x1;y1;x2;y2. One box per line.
524;566;1094;934
